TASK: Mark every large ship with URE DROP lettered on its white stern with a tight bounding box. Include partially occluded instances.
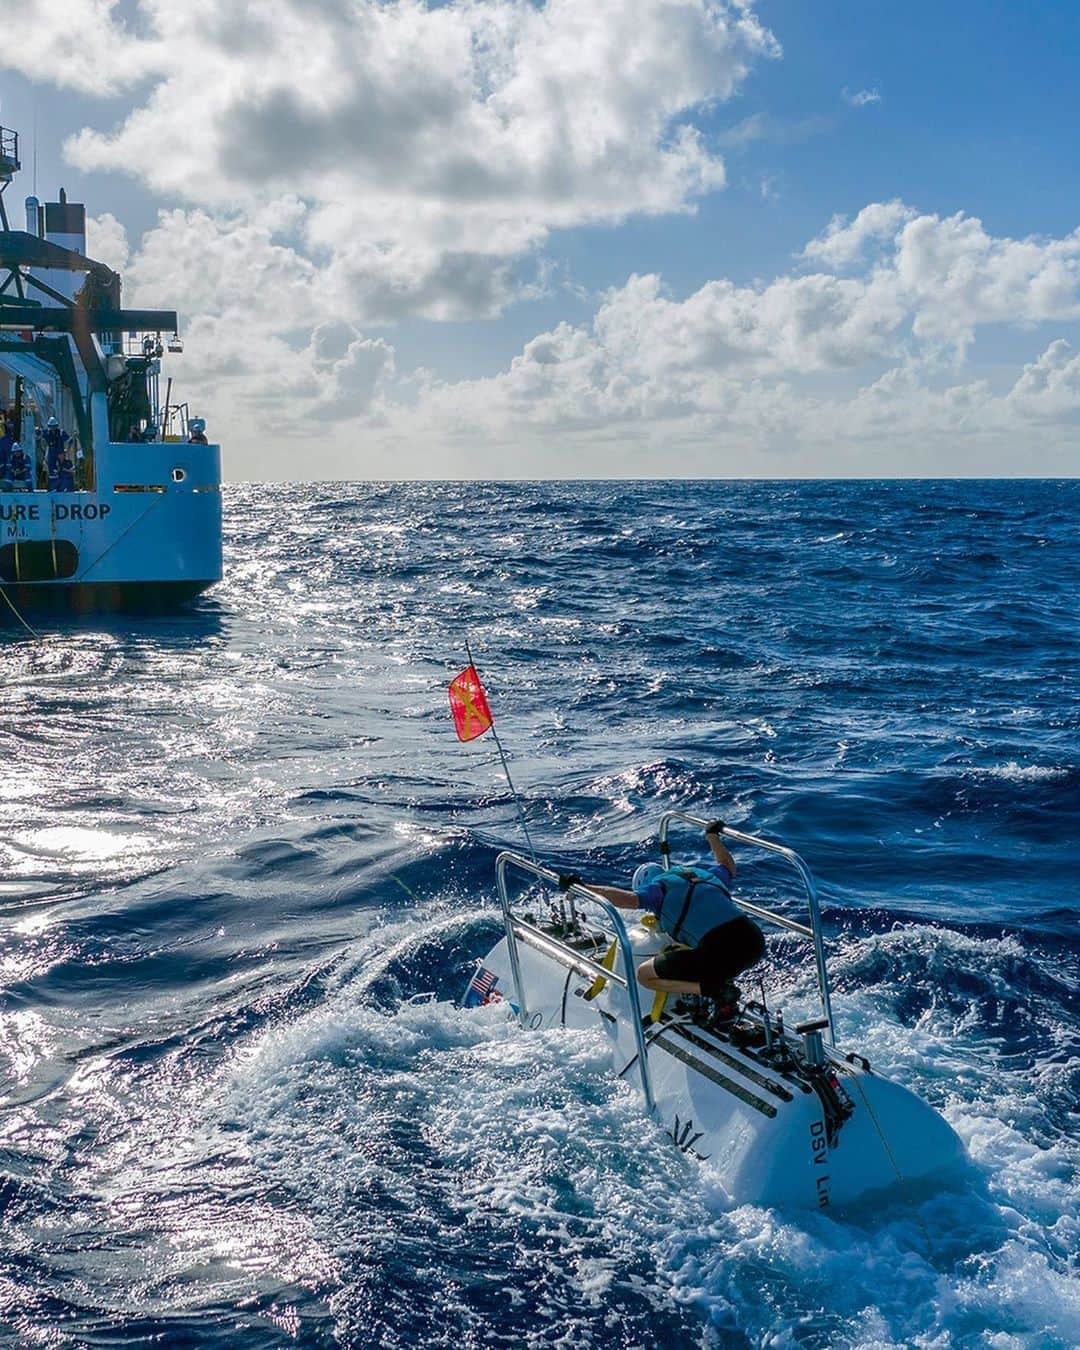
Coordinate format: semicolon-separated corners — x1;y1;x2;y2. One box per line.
0;127;221;626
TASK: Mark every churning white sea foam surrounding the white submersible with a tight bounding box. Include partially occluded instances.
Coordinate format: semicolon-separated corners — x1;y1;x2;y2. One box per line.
213;912;1080;1350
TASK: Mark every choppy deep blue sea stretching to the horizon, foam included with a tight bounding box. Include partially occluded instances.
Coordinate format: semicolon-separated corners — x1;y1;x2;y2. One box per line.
0;482;1080;1350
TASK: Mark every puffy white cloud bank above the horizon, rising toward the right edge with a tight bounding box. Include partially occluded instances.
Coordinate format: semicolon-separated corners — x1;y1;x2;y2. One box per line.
345;203;1080;477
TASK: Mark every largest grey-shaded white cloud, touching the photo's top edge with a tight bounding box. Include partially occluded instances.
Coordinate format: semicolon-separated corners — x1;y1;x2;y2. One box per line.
12;0;779;321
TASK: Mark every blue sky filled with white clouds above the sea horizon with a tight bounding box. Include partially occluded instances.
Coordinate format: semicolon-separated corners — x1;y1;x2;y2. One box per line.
0;0;1080;481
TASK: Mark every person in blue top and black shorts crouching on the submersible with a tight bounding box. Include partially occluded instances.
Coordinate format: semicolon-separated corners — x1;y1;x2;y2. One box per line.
569;821;765;1015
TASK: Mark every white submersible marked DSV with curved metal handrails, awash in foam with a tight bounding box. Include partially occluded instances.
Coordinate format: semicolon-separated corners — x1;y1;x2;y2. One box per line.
464;813;965;1210
